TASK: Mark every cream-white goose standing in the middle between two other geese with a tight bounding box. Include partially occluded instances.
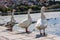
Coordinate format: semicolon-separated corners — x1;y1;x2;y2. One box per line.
18;9;32;33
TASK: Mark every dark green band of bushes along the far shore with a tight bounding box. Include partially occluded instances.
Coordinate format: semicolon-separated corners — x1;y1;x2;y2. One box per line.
0;4;60;13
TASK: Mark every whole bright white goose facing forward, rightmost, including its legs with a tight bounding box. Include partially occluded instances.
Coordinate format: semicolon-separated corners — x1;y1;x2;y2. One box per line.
36;6;47;35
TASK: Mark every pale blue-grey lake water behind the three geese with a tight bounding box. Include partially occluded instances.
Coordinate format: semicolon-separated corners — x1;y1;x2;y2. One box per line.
0;12;60;36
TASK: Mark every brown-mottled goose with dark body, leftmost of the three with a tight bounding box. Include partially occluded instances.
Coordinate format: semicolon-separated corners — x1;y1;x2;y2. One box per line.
4;9;16;31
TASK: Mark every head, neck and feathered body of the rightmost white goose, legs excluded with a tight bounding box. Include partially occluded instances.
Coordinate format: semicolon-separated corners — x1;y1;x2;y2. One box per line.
36;7;47;29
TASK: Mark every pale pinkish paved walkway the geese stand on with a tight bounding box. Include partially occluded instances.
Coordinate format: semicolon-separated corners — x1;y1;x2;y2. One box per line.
0;26;60;40
